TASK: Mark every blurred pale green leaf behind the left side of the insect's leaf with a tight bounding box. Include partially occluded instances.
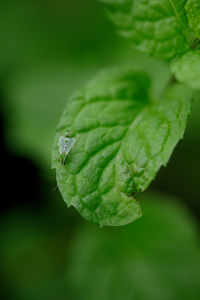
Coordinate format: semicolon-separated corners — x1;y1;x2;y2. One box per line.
0;44;170;170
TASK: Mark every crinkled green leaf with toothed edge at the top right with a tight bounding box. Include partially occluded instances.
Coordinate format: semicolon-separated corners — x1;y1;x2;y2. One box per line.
102;0;193;59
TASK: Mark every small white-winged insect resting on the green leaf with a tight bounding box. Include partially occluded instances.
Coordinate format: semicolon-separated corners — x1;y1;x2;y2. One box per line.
59;131;75;165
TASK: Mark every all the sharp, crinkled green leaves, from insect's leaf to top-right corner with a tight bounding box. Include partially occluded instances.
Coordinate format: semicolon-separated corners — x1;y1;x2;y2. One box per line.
52;0;200;226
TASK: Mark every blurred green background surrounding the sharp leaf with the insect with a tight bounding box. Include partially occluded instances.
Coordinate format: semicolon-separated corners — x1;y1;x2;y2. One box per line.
0;0;200;300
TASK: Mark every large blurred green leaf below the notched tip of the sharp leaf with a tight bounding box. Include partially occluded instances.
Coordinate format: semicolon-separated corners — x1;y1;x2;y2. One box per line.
67;193;200;300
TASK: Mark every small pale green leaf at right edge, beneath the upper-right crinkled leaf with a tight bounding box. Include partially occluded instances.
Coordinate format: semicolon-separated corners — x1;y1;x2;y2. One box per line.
170;49;200;89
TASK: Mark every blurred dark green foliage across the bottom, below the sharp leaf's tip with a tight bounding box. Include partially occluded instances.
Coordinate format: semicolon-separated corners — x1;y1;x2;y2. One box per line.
0;192;200;300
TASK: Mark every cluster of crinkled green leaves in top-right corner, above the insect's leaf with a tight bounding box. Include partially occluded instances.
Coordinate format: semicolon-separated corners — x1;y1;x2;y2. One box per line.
102;0;200;89
